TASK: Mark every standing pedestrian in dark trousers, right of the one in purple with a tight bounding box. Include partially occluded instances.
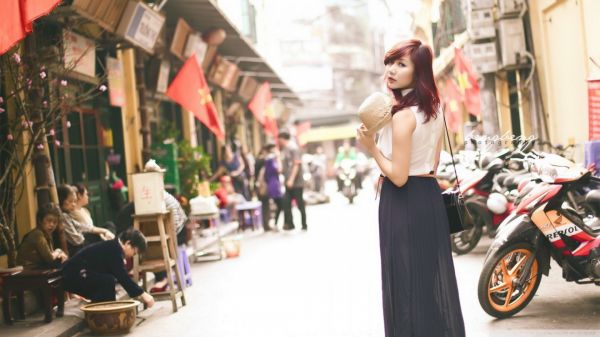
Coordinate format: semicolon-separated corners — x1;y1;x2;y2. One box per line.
277;131;308;231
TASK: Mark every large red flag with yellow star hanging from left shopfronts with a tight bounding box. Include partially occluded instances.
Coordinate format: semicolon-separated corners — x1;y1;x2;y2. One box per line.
167;55;225;140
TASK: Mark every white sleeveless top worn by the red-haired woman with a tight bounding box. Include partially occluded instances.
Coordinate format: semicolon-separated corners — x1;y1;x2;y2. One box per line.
377;106;444;176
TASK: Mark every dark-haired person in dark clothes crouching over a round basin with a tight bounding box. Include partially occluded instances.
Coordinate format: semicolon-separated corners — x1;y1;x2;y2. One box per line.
63;229;154;307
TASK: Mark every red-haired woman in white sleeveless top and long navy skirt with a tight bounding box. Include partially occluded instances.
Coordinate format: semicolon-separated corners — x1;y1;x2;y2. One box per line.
357;40;465;337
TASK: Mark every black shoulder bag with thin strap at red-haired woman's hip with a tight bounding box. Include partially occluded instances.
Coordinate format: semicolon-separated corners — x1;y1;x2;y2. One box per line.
442;112;467;234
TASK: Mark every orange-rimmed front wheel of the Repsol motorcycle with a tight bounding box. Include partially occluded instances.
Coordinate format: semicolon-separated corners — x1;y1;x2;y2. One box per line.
477;243;542;318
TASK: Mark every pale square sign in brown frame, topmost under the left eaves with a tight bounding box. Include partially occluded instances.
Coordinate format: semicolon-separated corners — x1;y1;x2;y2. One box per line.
117;1;165;54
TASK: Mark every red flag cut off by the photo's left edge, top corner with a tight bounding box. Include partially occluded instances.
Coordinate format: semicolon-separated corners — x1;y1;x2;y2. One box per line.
0;0;27;55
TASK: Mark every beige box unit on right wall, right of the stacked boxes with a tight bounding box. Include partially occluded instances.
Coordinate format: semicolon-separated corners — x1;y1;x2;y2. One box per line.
498;18;527;67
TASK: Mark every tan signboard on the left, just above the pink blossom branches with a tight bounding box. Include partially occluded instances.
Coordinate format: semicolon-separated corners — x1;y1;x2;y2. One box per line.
63;30;96;77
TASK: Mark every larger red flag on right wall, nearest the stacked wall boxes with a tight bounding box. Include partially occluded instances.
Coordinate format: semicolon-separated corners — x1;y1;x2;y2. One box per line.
454;48;481;116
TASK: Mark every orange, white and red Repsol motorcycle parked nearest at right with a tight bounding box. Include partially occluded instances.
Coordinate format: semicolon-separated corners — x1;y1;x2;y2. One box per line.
478;151;600;318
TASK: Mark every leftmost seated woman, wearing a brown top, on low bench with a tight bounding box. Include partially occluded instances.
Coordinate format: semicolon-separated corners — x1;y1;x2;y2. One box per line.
17;204;67;269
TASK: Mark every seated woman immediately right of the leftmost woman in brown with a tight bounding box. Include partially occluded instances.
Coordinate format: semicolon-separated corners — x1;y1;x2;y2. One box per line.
56;185;114;256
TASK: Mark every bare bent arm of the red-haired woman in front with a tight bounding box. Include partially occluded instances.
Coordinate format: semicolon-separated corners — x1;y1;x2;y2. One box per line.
358;108;417;187
